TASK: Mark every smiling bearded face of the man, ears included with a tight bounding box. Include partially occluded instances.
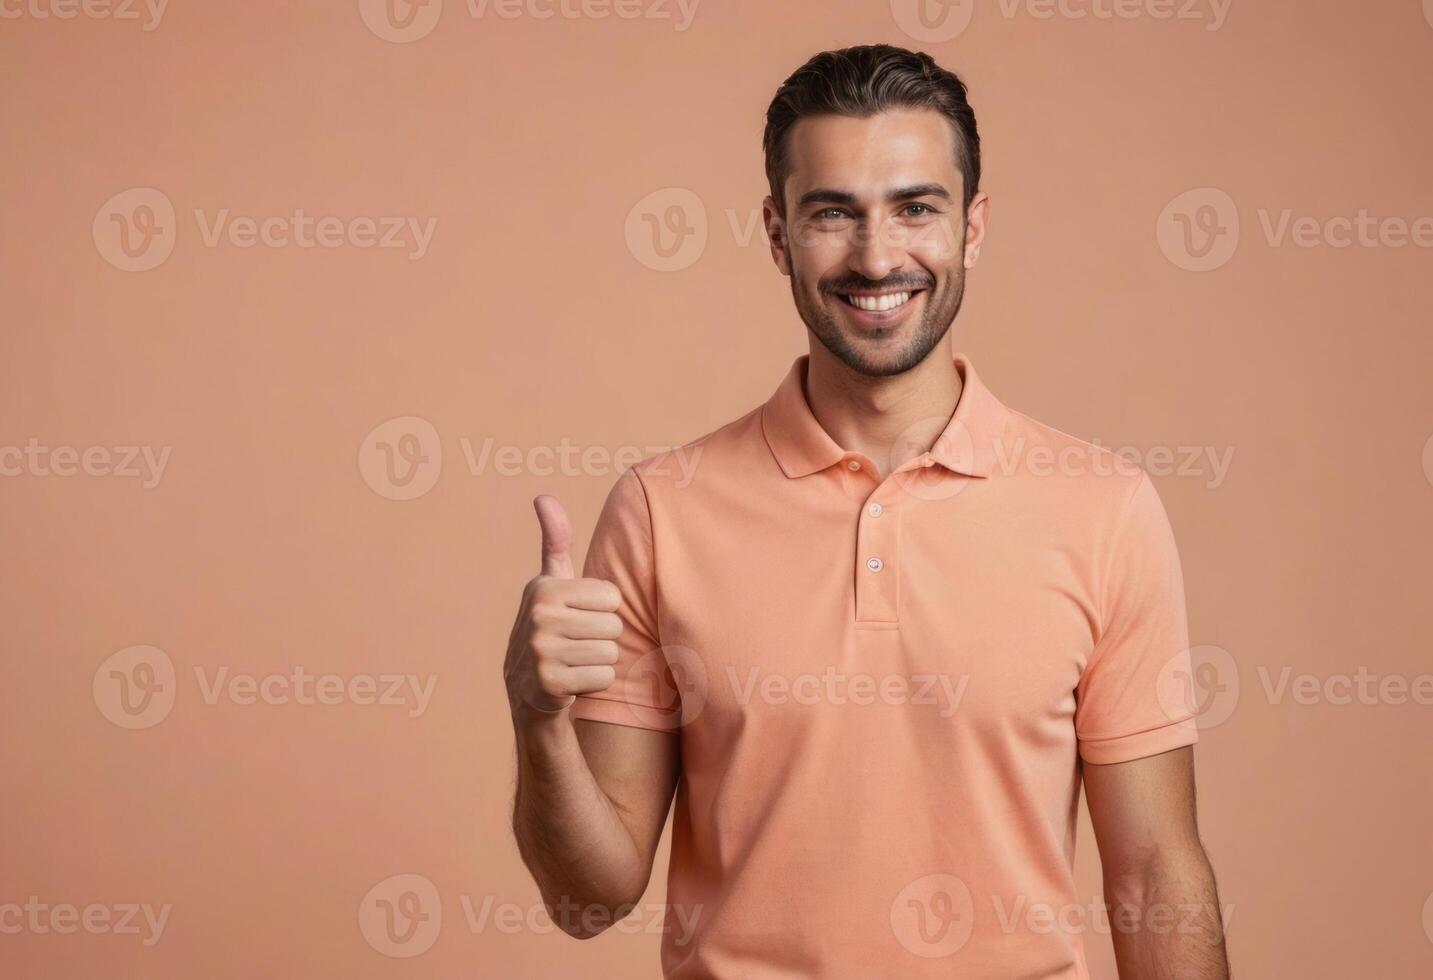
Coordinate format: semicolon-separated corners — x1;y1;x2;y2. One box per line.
765;109;986;377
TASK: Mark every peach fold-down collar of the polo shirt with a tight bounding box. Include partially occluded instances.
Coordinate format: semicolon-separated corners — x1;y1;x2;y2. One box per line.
761;352;1009;479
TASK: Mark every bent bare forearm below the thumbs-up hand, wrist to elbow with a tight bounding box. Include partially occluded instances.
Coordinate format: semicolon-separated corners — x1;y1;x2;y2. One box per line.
513;711;648;938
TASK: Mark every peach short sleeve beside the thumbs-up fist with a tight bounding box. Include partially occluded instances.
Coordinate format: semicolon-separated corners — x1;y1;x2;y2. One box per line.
569;470;679;731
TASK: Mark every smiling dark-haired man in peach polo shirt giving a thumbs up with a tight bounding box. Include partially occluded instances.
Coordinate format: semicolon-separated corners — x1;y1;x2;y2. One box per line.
504;46;1228;980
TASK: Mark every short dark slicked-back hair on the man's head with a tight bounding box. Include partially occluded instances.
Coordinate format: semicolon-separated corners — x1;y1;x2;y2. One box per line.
761;44;980;216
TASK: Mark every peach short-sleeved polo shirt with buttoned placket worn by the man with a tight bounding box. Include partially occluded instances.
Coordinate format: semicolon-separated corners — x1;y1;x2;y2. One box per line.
570;354;1198;980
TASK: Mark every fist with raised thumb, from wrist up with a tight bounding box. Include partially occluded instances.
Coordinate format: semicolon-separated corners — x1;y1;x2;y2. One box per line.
503;494;622;718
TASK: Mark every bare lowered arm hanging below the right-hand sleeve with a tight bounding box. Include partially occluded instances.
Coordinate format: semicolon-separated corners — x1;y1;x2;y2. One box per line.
1085;746;1230;980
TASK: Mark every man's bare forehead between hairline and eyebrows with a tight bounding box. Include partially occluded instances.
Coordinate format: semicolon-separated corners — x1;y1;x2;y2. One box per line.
785;109;962;201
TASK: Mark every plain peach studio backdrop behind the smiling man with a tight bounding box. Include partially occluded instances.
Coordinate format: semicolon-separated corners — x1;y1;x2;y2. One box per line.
0;0;1433;980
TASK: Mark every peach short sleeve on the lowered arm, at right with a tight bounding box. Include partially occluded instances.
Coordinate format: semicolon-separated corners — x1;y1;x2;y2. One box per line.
1075;473;1199;765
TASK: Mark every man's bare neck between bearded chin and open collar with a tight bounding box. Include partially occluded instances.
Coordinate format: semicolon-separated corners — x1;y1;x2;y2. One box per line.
805;338;963;479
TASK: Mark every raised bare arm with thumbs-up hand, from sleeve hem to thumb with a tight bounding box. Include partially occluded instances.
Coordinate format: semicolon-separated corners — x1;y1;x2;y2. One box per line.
503;497;678;938
